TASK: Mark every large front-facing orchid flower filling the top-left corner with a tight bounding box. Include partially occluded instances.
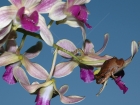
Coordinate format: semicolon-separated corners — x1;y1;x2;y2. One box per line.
0;0;59;46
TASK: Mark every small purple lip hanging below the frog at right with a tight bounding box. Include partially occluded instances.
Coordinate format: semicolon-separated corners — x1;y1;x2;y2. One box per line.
114;77;128;94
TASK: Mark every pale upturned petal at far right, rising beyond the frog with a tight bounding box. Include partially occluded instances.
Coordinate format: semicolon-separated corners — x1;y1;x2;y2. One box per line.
124;41;138;67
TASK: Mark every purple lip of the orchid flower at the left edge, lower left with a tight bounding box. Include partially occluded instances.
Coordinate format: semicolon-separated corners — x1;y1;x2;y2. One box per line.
2;65;17;84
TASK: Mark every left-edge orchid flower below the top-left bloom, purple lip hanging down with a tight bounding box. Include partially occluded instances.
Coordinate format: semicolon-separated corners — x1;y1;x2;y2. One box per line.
0;40;46;84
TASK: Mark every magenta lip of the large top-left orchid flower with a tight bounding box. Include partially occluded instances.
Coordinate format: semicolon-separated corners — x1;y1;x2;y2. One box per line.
17;7;40;32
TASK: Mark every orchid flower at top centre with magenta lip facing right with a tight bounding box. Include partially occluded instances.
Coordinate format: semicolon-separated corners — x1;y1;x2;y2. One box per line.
49;0;92;39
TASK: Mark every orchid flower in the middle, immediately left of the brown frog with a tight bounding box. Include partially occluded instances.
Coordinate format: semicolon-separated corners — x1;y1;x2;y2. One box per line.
53;34;112;83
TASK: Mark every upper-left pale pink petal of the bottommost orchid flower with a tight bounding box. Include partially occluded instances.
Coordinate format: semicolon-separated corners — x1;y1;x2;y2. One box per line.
13;66;30;85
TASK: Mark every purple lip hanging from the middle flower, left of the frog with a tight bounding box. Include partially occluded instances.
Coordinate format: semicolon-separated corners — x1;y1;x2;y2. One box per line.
80;66;94;83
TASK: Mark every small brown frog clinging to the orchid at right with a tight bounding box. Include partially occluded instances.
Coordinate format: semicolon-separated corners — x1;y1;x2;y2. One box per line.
95;57;125;84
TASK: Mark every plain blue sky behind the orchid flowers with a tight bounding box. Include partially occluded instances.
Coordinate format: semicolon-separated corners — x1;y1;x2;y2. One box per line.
0;0;140;105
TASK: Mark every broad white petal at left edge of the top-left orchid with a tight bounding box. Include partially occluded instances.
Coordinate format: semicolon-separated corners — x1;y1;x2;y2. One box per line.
0;6;17;29
